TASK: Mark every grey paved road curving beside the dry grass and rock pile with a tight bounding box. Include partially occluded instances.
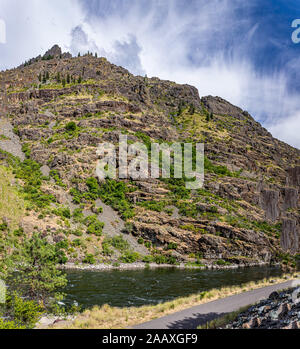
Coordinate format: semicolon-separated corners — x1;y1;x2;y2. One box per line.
133;281;292;329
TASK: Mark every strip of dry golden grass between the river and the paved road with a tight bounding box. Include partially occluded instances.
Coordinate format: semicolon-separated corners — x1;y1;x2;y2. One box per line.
51;274;296;329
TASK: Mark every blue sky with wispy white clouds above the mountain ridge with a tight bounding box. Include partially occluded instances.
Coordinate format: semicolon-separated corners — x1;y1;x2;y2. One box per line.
0;0;300;148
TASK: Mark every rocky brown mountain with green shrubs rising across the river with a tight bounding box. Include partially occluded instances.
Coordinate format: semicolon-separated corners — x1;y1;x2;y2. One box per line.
0;46;300;266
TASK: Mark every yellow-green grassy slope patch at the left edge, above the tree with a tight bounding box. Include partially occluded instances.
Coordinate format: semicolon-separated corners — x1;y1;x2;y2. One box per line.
0;166;24;228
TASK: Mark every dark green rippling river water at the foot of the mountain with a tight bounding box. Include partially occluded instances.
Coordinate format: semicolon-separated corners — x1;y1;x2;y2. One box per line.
64;267;282;308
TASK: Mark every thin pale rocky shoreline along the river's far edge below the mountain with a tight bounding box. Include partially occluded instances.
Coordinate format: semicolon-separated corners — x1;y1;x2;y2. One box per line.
59;262;280;271
